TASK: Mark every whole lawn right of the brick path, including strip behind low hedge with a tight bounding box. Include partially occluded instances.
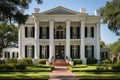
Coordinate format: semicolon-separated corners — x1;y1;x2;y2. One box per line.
68;65;120;79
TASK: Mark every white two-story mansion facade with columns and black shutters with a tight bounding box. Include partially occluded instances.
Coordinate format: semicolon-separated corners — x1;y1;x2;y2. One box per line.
19;6;100;63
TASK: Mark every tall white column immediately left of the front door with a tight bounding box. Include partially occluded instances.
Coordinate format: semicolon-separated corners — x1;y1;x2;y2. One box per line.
49;21;54;58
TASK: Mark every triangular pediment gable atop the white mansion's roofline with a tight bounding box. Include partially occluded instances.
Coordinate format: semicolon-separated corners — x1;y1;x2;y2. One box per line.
42;6;79;14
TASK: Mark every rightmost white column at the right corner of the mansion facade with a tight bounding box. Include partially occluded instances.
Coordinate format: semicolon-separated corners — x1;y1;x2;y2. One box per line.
96;23;100;63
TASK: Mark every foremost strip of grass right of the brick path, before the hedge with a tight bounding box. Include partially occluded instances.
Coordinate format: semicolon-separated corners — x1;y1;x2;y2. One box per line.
73;72;120;79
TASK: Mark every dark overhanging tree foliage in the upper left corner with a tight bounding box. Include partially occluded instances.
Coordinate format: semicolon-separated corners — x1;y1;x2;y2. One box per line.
0;0;42;24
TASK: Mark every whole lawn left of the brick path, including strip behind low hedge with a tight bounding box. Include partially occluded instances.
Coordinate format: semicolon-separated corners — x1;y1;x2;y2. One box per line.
0;66;52;79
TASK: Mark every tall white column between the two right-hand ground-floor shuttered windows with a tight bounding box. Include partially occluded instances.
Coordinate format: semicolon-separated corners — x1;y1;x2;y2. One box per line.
80;20;86;64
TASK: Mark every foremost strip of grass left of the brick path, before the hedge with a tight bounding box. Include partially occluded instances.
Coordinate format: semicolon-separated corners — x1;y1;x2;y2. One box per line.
0;72;49;79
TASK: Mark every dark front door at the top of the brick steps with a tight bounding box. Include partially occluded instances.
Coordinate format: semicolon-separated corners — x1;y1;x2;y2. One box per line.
55;45;65;59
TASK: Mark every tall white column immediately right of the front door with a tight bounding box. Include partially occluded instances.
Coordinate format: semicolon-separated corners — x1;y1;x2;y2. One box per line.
66;21;70;58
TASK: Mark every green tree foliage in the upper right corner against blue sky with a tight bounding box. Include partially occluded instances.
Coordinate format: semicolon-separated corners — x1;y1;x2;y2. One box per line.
100;0;120;35
